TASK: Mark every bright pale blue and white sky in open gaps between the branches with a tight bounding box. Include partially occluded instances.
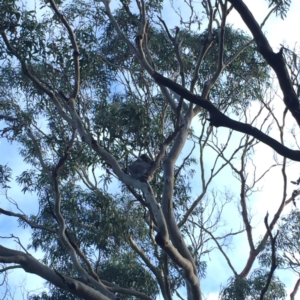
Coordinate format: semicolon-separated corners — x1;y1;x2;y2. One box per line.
0;0;300;300
